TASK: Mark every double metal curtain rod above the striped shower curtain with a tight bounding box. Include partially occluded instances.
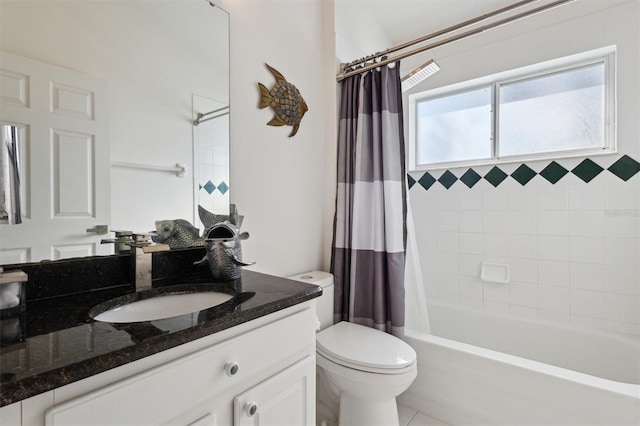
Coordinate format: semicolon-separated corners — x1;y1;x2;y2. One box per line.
336;0;575;81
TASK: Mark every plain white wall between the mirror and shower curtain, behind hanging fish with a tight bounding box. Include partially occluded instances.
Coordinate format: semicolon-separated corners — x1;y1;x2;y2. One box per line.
219;0;336;275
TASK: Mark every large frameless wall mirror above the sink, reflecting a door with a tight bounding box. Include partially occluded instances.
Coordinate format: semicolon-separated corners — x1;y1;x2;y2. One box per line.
0;0;229;265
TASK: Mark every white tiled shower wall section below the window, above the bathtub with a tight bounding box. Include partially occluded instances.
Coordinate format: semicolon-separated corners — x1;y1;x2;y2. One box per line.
410;156;640;335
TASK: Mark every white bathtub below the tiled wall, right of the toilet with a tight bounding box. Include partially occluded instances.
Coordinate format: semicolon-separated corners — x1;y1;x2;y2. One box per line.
399;303;640;426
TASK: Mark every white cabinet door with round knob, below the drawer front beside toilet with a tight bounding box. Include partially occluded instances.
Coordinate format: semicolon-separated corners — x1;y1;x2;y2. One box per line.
233;356;316;426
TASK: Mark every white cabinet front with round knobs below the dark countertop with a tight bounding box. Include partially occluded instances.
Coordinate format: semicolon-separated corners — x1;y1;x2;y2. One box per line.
3;303;315;426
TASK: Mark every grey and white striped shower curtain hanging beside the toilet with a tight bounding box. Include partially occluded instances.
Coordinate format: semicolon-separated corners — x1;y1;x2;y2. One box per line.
331;62;406;337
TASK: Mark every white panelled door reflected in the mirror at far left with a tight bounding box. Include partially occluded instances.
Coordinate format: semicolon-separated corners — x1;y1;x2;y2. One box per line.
0;52;113;264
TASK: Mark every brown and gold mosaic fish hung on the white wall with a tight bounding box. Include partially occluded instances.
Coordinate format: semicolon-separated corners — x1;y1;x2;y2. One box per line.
258;64;309;137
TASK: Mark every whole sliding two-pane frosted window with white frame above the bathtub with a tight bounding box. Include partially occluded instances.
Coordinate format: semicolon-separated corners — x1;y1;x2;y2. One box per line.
409;48;615;170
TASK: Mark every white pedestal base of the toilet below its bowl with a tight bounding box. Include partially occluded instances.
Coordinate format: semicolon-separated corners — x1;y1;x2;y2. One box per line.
338;393;399;426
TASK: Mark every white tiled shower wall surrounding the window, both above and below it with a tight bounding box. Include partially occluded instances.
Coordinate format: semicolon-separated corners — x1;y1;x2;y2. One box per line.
409;0;640;336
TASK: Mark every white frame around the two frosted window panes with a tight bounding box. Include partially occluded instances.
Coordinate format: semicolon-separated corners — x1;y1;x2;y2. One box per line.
408;46;617;171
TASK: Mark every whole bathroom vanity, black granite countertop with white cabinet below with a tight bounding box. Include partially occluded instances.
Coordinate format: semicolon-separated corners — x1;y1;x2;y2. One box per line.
0;250;321;426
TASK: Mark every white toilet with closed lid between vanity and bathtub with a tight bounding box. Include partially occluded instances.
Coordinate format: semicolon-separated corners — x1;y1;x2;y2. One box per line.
290;271;417;426
